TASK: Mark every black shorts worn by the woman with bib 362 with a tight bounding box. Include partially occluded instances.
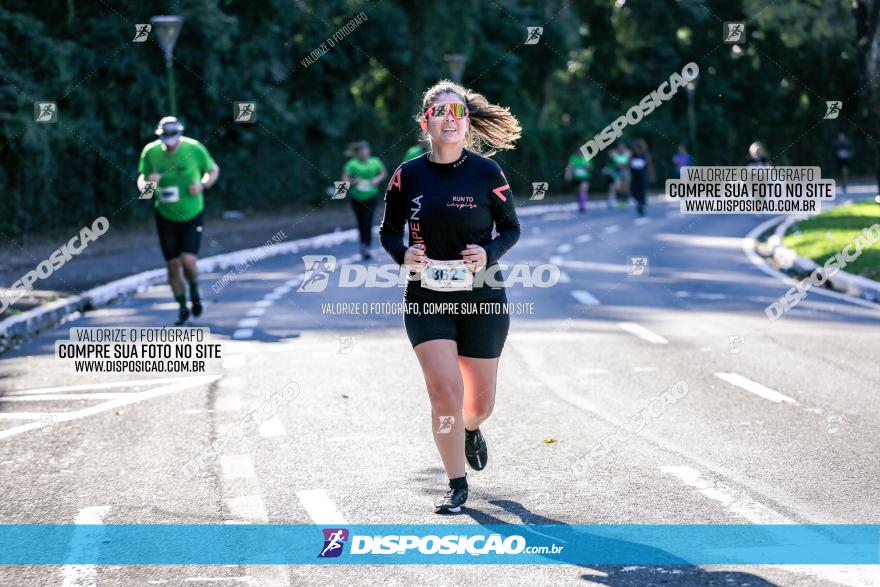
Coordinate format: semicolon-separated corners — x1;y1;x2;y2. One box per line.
403;289;510;359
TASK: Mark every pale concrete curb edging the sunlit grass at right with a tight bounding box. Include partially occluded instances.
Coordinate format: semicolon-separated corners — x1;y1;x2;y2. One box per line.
764;215;880;303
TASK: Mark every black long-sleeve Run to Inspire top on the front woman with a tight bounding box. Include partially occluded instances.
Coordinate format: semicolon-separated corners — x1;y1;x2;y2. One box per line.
379;149;520;301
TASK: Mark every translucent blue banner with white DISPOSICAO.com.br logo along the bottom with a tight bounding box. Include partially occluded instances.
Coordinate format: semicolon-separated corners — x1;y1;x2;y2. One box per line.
0;524;880;565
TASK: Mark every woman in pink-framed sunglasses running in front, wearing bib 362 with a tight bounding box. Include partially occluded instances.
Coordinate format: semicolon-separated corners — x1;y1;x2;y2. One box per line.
379;80;522;513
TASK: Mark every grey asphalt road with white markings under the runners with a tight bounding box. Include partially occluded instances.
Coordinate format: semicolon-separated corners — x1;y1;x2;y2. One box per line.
0;193;880;586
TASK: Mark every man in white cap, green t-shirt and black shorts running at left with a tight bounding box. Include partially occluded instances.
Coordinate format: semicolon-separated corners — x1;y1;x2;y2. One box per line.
137;116;220;326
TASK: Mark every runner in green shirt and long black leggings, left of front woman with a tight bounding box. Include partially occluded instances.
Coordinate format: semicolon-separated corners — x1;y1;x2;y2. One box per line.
342;141;388;261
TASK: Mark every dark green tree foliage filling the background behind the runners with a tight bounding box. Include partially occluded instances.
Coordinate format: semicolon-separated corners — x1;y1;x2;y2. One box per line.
0;0;873;235
